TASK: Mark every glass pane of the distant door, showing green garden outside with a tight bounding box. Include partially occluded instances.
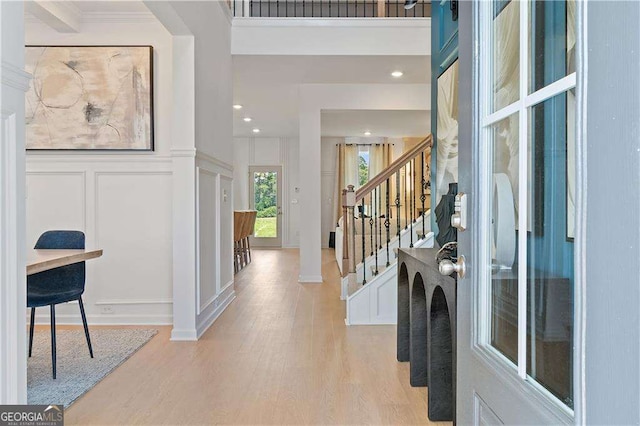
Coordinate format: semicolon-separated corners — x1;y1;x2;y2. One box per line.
252;171;278;238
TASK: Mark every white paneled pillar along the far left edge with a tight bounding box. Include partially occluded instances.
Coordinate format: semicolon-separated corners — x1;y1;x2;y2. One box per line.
0;2;30;404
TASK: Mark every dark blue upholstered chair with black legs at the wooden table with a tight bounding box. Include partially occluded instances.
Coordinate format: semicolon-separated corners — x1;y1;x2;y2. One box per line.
27;231;93;379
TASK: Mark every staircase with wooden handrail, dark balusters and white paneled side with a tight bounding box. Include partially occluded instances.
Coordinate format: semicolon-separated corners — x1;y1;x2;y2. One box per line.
336;135;434;325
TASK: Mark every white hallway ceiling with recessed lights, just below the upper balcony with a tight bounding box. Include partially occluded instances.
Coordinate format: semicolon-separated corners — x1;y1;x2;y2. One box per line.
233;55;430;137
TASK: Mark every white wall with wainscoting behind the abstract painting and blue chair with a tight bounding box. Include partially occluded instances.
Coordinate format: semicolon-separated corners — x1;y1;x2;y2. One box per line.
26;19;173;324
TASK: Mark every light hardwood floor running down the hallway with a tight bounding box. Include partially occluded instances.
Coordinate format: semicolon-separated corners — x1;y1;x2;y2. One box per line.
65;250;447;425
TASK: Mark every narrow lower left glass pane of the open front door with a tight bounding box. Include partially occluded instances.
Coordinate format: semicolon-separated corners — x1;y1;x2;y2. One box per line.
488;114;519;364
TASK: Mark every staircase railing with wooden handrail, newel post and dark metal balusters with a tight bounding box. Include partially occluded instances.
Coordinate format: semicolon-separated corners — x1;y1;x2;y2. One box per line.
342;135;433;288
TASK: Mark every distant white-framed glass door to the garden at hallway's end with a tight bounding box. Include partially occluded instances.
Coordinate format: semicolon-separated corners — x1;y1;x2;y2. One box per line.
249;166;282;247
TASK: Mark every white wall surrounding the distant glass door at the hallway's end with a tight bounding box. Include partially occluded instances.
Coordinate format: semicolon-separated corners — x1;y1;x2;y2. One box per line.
233;137;300;247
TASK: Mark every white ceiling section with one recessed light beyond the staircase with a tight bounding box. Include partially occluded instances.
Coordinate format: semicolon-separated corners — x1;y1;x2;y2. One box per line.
321;110;431;137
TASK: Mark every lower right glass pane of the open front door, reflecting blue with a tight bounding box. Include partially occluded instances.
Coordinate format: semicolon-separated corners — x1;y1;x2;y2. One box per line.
527;90;575;408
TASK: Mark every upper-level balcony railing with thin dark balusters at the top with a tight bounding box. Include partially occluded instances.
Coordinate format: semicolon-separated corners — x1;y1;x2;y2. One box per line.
227;0;431;18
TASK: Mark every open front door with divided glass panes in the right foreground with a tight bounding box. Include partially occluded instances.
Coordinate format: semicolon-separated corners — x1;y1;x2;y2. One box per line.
457;0;577;424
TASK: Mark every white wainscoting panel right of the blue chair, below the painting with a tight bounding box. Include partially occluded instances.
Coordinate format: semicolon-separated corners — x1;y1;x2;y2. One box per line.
92;171;172;315
